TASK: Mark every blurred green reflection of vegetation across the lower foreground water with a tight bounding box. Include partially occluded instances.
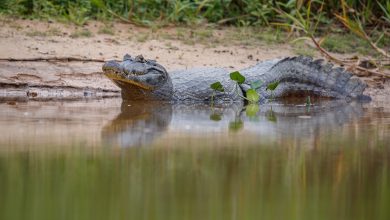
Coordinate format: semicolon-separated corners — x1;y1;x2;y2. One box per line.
0;139;390;220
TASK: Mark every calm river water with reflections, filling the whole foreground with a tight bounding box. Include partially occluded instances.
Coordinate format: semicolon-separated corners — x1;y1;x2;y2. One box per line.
0;99;390;220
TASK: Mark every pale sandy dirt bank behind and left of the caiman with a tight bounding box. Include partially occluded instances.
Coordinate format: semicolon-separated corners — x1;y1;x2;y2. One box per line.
0;18;390;103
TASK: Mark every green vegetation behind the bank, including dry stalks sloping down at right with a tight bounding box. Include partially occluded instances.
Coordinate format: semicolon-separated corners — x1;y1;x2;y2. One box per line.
0;0;390;75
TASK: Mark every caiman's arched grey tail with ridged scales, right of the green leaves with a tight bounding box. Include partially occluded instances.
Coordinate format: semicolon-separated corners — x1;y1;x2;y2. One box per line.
254;56;370;100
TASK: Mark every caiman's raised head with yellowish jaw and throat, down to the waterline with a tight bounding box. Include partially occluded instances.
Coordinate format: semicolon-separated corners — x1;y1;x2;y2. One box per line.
103;54;172;100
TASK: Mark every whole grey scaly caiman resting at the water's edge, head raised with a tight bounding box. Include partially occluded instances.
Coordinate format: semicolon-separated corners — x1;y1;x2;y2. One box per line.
103;54;370;102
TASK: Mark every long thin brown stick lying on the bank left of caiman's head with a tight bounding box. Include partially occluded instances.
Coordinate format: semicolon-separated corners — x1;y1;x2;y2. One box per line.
0;57;106;63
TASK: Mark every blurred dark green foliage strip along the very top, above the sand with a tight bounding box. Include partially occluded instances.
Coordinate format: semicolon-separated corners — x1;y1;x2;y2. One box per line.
0;0;390;26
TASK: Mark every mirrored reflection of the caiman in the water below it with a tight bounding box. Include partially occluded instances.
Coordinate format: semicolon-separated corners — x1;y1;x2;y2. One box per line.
102;100;363;147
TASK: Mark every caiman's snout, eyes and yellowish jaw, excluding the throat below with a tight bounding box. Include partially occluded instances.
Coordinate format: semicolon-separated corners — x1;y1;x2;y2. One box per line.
103;55;168;92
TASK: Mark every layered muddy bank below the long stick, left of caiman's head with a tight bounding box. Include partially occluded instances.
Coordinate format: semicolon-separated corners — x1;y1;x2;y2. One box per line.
0;62;120;100
